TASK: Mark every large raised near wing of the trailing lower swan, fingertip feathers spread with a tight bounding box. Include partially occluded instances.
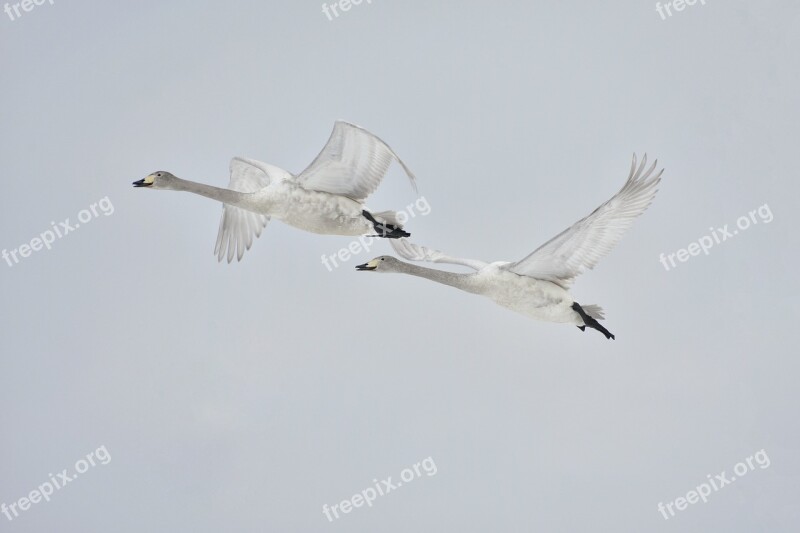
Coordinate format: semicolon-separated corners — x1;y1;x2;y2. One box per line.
505;154;664;288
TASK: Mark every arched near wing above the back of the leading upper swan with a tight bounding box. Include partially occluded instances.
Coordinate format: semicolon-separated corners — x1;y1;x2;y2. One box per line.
297;120;417;200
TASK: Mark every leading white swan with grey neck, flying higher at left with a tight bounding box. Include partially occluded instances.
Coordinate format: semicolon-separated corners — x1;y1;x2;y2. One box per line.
133;120;416;263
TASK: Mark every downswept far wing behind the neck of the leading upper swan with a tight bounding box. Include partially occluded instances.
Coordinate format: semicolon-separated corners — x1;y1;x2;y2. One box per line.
214;157;292;263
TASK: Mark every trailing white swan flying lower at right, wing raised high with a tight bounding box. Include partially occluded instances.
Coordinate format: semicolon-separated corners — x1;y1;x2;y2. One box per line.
356;154;664;339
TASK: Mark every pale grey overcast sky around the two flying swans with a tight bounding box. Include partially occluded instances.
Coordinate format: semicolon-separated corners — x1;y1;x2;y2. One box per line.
0;0;800;533
